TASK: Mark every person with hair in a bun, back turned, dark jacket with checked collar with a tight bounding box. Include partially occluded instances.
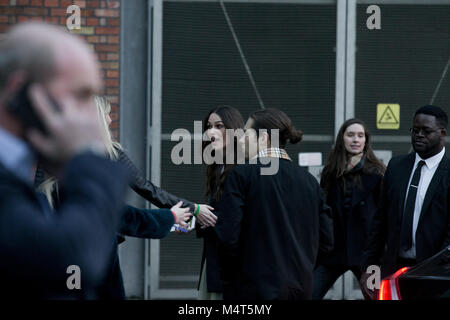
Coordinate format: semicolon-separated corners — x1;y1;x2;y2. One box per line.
215;109;333;300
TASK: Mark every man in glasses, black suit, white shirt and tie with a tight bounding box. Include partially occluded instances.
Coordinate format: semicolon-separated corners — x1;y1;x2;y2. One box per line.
361;105;450;298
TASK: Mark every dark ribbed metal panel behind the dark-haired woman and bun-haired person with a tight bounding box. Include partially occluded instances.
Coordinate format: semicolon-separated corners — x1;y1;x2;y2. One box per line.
160;2;336;288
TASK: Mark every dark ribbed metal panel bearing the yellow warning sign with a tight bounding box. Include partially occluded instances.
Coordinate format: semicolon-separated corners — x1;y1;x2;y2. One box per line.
355;5;450;149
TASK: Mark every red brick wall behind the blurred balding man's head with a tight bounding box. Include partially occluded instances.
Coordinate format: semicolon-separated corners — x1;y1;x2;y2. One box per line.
0;0;120;139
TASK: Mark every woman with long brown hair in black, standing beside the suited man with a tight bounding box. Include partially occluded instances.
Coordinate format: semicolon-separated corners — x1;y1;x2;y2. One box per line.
313;118;386;299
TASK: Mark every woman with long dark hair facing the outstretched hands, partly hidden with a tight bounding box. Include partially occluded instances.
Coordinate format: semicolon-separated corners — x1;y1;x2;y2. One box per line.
197;106;244;300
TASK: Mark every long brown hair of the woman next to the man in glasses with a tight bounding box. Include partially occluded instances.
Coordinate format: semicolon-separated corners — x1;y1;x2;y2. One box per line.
321;118;386;194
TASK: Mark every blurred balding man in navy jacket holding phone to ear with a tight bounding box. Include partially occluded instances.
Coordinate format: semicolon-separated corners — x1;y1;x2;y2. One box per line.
0;23;128;299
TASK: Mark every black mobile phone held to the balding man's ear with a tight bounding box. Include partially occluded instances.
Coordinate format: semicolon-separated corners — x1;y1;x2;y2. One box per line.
7;82;60;134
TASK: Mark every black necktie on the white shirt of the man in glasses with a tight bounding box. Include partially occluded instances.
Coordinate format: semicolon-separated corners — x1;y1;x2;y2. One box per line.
400;160;425;251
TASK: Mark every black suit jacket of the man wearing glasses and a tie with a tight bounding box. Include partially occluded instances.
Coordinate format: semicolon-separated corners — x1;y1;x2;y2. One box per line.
363;153;450;277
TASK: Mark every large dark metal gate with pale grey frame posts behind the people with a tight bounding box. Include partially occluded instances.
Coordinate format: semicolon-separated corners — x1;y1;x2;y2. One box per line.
118;0;450;299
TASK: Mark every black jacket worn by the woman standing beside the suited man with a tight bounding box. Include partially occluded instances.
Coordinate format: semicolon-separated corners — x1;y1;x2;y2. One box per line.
321;158;383;268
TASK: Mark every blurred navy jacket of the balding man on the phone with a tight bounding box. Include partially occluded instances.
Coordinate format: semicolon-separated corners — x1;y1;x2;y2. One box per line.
0;153;128;299
